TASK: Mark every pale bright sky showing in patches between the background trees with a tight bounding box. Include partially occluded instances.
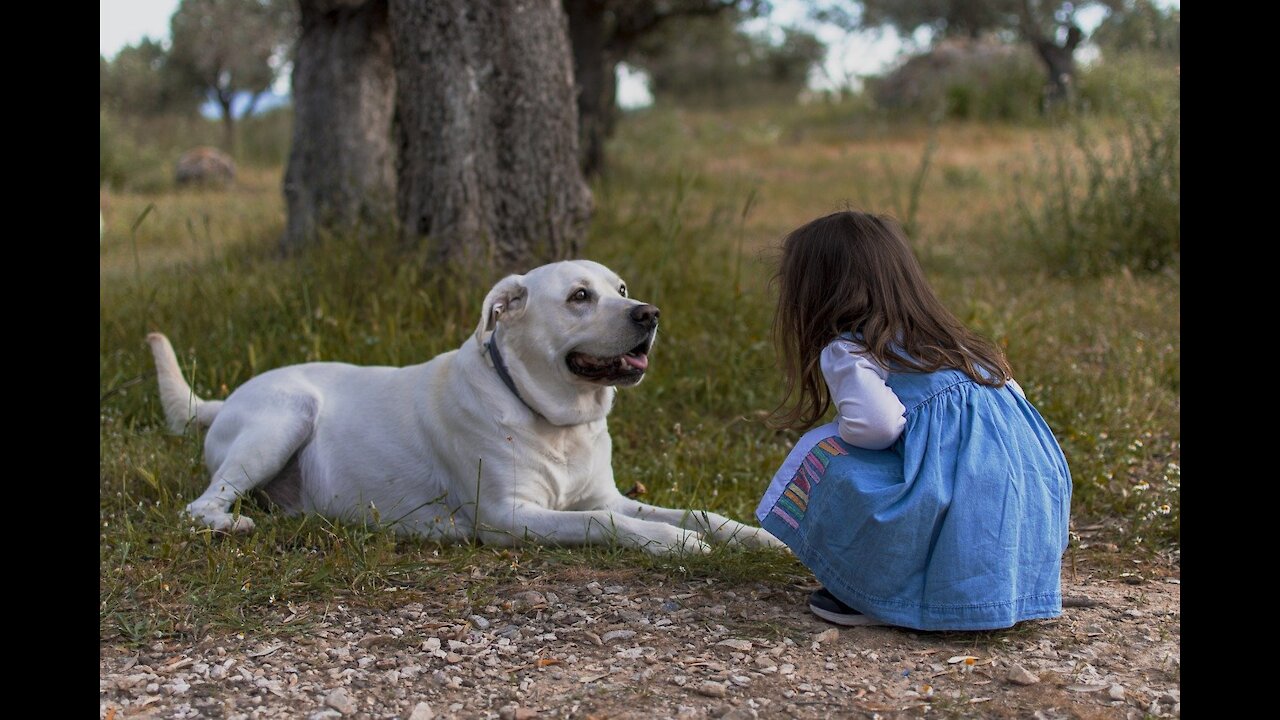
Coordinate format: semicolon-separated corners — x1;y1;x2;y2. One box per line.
99;0;1181;108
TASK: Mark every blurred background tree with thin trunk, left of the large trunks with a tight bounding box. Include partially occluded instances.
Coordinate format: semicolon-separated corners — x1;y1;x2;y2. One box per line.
169;0;297;154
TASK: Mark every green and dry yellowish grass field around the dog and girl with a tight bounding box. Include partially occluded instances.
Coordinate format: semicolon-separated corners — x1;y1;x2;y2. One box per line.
100;98;1180;643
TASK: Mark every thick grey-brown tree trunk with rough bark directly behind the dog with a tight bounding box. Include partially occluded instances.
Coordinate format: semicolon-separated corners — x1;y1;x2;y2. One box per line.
390;0;591;270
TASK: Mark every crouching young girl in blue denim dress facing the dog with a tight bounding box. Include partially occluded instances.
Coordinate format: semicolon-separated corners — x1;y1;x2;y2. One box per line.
755;211;1071;630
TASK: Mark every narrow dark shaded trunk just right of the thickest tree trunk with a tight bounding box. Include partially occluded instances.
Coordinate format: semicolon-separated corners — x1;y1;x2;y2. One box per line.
564;0;618;177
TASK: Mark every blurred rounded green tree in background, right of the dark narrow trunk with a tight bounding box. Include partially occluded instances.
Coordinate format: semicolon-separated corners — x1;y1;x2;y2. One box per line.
632;12;826;106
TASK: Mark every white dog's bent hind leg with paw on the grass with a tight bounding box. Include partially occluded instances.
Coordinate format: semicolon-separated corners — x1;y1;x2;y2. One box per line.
187;405;312;533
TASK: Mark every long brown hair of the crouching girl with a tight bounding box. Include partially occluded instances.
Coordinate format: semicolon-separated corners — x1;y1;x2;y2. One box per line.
771;210;1012;429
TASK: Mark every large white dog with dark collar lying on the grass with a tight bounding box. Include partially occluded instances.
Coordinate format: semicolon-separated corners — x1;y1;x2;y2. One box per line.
147;260;783;552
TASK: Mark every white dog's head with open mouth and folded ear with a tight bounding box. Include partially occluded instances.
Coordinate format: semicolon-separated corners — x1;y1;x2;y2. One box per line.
475;260;658;424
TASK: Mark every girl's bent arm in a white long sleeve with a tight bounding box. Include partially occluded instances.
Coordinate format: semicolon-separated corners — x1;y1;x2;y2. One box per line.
820;340;906;450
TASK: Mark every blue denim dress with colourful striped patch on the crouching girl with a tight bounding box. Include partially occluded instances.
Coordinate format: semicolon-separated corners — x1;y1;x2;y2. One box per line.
755;370;1071;630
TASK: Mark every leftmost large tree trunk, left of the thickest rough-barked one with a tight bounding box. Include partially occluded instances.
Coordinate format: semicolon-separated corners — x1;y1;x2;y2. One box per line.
282;0;396;250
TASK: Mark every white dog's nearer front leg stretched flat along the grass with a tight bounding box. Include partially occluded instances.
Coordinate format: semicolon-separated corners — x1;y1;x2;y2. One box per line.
476;503;710;555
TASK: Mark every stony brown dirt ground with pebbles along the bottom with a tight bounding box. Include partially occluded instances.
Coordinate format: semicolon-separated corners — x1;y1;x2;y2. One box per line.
100;545;1180;720
